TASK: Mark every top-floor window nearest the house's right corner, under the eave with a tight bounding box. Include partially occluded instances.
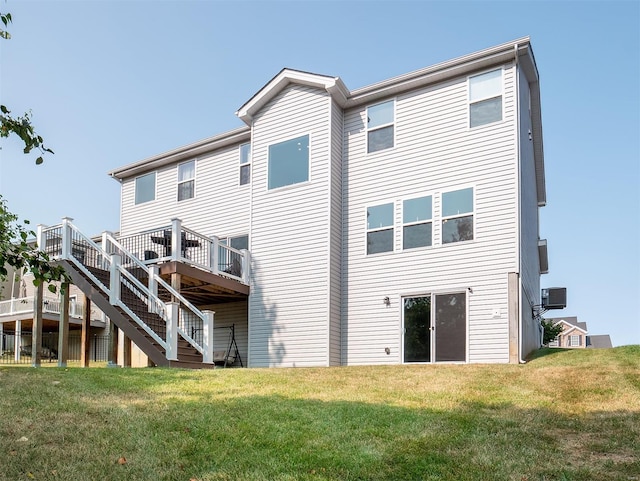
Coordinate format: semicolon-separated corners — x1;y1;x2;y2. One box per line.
469;69;502;127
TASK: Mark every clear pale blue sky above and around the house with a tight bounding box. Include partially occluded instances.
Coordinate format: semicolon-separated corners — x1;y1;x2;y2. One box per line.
0;0;640;346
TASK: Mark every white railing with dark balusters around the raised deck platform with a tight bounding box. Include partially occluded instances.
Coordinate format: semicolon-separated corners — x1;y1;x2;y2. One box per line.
118;219;249;284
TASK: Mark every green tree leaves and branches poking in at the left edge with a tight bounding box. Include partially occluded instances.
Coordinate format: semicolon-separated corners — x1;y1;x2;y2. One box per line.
0;13;70;292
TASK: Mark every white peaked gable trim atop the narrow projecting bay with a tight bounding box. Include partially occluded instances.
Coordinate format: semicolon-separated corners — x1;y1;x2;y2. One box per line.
236;68;349;125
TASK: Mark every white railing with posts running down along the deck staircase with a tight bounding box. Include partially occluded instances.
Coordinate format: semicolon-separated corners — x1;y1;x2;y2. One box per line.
38;218;218;363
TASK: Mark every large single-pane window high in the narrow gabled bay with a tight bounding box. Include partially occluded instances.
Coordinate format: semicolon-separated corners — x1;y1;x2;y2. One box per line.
268;135;309;189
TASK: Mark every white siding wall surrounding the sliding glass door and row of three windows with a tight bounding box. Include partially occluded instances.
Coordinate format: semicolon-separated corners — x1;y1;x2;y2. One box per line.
342;66;518;364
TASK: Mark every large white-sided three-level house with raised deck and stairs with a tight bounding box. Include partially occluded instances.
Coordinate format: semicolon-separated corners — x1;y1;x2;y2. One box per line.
41;38;548;367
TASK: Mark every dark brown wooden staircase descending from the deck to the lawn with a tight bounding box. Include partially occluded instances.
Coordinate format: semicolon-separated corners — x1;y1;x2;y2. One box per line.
59;260;214;369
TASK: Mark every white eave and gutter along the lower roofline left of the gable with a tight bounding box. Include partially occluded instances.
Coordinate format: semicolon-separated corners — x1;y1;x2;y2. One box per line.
109;126;251;180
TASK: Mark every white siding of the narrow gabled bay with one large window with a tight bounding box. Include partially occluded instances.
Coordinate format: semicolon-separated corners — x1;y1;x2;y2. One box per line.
249;85;331;366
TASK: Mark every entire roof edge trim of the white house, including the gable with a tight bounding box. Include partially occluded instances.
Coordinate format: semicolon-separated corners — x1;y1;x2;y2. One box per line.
109;37;546;206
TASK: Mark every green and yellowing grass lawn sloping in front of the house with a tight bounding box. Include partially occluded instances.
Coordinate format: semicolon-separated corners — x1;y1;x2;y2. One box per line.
0;346;640;481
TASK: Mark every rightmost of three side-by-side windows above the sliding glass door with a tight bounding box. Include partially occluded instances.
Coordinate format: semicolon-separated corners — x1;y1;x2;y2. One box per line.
442;187;473;244
